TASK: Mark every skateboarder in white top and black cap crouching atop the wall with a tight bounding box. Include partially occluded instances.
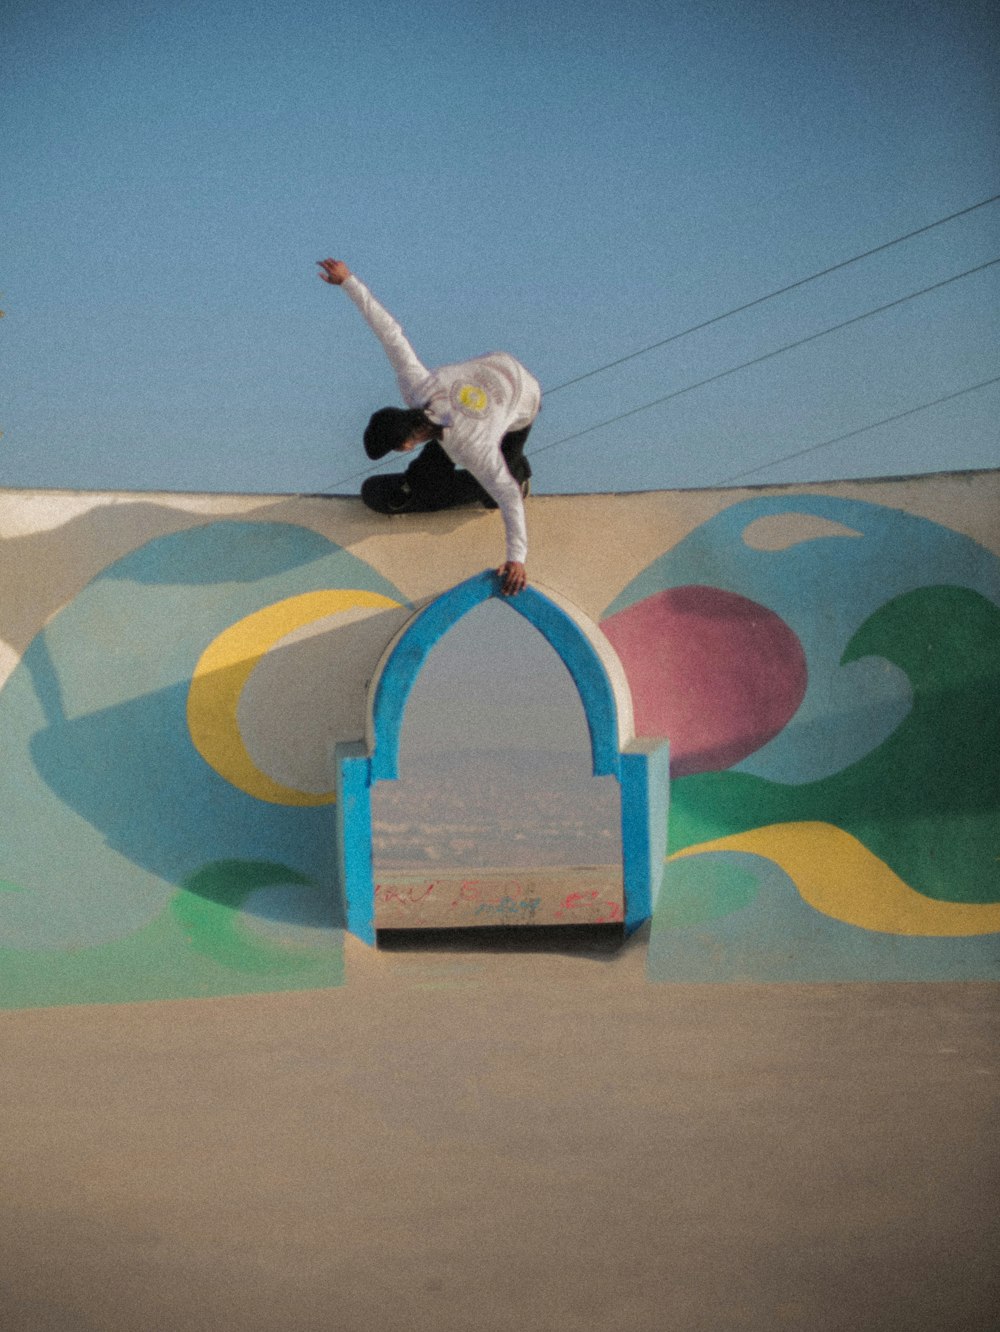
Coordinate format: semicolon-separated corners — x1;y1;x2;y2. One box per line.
318;258;542;595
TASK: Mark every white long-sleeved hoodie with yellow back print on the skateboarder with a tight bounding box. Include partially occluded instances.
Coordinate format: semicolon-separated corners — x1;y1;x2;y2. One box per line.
344;274;542;563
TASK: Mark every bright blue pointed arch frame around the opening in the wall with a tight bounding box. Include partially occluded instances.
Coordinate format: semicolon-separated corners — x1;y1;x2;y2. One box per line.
334;570;668;943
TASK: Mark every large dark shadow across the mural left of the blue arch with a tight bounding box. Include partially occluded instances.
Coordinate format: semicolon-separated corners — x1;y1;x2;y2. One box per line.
23;613;423;927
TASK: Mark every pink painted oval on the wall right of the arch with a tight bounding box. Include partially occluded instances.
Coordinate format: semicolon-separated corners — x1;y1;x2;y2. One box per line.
601;586;807;777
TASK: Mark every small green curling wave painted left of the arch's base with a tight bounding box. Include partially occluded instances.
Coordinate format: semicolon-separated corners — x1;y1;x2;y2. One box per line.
170;860;328;974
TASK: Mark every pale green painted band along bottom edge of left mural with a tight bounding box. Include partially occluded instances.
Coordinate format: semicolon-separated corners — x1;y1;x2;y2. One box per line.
0;911;345;1008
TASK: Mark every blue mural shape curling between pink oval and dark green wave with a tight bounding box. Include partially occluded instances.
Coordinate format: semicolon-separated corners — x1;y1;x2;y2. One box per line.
605;494;1000;785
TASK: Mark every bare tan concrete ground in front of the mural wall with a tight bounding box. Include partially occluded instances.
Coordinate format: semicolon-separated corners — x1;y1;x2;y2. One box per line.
0;930;1000;1332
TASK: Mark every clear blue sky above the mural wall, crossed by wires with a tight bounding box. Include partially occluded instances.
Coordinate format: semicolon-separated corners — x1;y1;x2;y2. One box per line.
0;0;1000;493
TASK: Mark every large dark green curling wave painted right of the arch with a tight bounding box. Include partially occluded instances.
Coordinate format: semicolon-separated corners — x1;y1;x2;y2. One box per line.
670;587;1000;902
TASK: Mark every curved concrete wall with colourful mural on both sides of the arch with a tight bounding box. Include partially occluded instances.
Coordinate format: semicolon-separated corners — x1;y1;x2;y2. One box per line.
0;472;1000;1007
